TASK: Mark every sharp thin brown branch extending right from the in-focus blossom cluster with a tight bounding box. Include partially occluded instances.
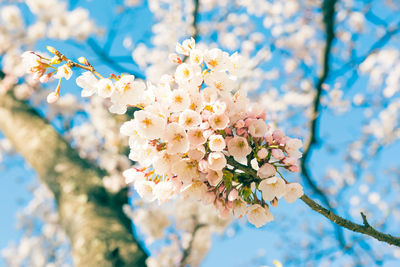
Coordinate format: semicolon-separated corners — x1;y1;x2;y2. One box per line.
301;195;400;247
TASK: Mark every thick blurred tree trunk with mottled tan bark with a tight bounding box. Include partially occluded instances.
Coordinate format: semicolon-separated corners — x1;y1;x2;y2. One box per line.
0;94;147;267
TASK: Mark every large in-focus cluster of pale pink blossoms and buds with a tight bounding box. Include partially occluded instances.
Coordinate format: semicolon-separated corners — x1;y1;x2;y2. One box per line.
25;39;303;227
